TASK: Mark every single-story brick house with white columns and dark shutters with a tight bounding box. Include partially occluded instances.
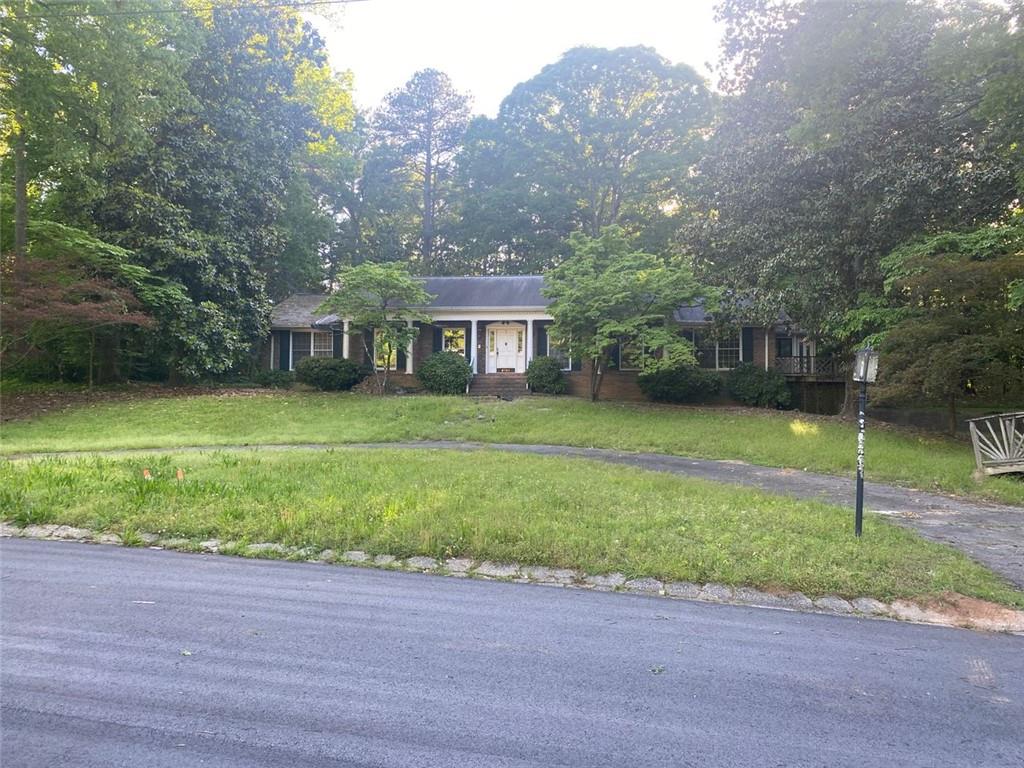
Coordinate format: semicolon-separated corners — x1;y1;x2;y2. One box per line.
263;275;841;400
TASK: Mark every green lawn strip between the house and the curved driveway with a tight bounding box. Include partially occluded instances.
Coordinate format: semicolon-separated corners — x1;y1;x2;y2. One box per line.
0;392;1024;505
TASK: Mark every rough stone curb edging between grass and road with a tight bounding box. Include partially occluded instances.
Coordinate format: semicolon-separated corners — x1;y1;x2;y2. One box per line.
0;522;1024;634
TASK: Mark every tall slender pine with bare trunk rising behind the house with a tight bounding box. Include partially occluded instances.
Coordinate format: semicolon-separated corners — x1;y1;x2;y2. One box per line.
374;70;469;273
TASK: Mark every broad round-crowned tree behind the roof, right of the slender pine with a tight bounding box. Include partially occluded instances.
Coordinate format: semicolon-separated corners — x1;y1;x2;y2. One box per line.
460;47;712;272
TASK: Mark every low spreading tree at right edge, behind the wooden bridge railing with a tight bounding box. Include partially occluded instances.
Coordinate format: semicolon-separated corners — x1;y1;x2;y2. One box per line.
873;222;1024;432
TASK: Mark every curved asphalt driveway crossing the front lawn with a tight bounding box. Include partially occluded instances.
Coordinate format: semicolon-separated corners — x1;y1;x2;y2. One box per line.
8;440;1024;589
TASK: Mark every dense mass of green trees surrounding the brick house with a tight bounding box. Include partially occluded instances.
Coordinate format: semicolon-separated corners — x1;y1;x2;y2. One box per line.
0;0;1024;410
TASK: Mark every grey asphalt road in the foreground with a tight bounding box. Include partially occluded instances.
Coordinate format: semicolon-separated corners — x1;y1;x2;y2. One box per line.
0;540;1024;768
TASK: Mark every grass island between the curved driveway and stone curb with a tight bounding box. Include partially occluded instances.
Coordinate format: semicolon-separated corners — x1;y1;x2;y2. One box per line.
0;449;1024;606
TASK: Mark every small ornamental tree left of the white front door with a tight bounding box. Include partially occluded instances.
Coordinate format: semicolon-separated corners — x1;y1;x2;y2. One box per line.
321;262;433;394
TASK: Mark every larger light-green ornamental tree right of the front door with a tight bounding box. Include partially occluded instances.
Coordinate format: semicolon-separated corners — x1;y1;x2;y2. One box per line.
544;226;700;400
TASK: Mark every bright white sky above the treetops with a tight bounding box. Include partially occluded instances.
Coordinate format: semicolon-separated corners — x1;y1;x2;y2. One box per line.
312;0;721;116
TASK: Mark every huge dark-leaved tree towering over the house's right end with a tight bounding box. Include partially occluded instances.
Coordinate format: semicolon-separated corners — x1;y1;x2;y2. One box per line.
689;0;1015;411
